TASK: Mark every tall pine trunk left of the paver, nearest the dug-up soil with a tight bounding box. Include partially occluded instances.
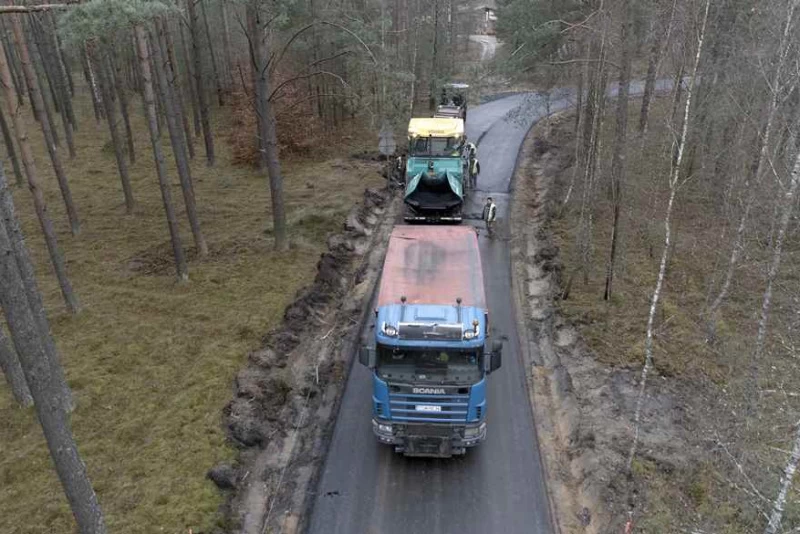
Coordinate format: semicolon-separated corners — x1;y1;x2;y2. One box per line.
247;2;289;251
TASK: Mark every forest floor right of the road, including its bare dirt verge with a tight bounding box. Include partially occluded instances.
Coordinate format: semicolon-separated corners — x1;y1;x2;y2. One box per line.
512;99;800;534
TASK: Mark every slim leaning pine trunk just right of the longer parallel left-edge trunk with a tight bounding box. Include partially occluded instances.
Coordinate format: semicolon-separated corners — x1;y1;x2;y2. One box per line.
8;14;81;235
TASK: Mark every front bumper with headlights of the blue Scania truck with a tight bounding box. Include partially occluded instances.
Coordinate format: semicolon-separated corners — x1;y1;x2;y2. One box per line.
372;419;486;458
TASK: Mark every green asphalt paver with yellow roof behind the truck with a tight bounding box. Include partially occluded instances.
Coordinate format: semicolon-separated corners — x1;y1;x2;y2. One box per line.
404;118;466;223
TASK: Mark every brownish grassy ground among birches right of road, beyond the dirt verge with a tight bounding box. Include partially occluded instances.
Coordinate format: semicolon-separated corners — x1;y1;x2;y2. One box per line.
554;99;800;534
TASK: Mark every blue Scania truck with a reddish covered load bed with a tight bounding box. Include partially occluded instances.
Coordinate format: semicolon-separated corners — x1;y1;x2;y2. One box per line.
359;226;502;458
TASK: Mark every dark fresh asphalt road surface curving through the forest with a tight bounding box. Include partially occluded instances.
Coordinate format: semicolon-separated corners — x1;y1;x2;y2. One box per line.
309;94;571;534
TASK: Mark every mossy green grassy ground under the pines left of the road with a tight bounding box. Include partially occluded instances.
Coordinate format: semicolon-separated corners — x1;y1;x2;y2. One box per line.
0;94;383;534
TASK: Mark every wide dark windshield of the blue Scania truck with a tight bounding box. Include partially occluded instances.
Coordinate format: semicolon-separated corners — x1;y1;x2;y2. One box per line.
377;346;482;384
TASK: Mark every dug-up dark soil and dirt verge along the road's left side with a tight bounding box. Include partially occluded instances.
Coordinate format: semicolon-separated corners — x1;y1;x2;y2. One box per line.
209;185;397;533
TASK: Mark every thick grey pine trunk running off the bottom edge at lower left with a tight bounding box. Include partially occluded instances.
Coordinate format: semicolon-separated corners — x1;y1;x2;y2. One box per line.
0;199;106;534
